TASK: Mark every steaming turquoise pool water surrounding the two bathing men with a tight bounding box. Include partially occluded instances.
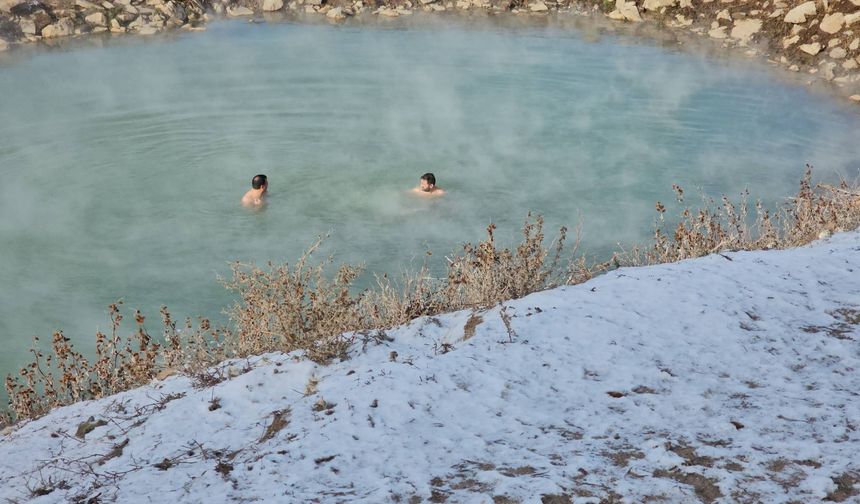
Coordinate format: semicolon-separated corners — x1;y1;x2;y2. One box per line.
0;15;860;402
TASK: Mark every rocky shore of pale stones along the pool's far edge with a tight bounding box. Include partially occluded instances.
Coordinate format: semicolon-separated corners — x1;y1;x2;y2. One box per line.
0;0;860;103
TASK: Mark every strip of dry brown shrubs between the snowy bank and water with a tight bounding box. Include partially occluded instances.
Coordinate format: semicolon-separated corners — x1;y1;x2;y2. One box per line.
0;168;860;426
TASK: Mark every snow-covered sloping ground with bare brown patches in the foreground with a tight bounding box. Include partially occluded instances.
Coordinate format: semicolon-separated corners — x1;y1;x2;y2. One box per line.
0;232;860;503
